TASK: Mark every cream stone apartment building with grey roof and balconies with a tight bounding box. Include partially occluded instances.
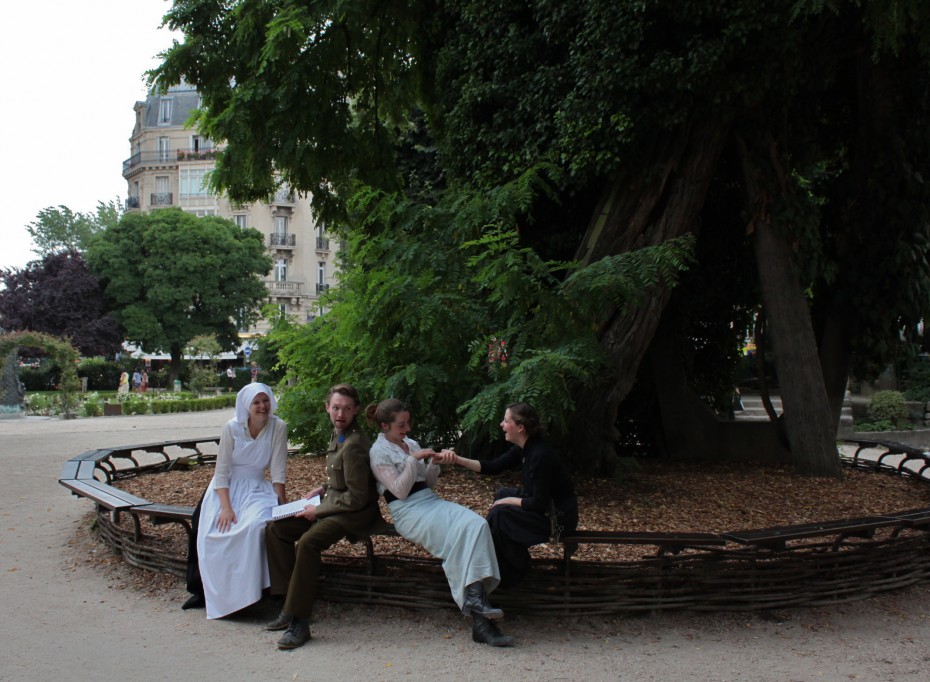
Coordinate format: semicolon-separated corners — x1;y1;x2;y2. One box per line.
123;85;338;337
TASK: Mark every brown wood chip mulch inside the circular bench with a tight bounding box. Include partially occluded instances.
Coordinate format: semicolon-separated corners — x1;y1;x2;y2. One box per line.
109;455;930;572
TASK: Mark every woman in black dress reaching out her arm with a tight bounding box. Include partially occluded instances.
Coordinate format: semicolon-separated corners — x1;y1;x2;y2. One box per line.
440;403;578;588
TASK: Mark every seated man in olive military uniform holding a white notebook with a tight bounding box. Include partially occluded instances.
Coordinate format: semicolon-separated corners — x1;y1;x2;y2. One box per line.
265;384;380;649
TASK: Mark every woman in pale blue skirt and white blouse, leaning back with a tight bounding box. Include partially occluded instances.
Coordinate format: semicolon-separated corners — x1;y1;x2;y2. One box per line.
366;398;513;646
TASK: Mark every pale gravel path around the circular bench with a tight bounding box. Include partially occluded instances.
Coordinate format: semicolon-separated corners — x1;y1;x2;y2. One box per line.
0;410;930;682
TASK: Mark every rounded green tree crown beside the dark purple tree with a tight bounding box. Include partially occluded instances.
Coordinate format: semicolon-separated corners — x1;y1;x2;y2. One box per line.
87;208;271;367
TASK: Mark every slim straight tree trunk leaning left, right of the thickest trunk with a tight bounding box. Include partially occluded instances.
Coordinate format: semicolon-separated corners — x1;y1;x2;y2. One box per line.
742;134;842;477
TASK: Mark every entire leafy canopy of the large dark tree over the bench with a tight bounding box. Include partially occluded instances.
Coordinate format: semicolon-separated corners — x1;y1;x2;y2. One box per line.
154;0;930;468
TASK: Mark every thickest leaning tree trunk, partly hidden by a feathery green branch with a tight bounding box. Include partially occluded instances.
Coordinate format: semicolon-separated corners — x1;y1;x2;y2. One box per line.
571;119;729;474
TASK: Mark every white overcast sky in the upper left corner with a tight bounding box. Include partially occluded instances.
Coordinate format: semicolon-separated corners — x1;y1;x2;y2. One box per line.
0;0;180;267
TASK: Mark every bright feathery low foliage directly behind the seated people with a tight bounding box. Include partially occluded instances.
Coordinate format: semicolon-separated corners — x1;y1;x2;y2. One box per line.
268;171;692;449
